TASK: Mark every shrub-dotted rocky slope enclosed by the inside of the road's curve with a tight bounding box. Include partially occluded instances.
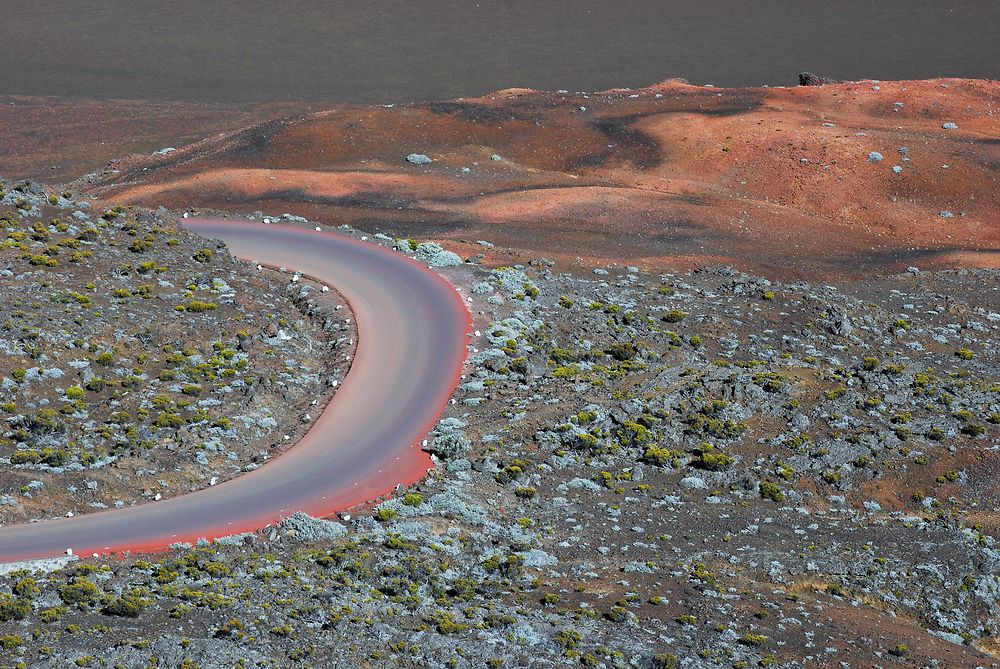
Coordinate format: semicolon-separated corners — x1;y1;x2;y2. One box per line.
0;181;355;523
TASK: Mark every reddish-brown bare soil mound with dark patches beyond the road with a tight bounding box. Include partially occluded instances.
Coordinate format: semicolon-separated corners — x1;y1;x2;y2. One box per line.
82;79;1000;277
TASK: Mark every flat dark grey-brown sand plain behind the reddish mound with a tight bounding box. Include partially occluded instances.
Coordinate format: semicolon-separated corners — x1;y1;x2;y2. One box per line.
0;0;1000;104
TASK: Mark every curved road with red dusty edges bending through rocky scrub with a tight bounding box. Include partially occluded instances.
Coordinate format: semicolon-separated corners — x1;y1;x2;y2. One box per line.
0;219;471;562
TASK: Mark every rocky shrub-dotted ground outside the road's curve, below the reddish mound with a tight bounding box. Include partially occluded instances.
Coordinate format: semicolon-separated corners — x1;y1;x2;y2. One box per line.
0;218;1000;669
